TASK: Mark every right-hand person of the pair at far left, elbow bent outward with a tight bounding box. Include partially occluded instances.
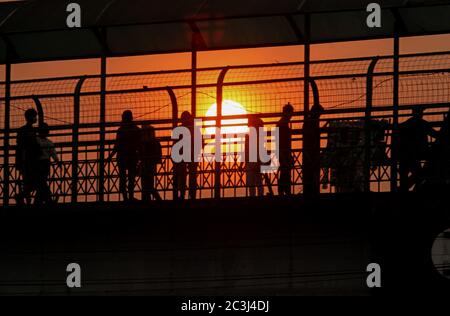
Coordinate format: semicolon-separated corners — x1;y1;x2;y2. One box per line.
35;123;60;205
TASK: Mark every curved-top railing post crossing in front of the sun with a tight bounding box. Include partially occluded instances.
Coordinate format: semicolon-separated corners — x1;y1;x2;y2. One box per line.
214;67;229;199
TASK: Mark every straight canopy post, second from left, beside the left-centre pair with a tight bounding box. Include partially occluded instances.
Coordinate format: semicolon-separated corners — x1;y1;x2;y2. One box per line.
98;56;107;202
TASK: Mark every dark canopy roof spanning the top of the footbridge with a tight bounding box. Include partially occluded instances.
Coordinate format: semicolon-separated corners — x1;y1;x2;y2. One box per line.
0;0;450;64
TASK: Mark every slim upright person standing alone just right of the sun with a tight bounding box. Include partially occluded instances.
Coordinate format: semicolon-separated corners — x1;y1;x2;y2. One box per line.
277;103;294;195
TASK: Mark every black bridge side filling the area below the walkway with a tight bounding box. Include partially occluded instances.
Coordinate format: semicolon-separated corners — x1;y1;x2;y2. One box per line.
0;194;450;295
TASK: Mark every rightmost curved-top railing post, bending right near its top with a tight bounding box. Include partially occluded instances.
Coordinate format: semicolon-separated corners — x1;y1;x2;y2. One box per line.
364;57;380;192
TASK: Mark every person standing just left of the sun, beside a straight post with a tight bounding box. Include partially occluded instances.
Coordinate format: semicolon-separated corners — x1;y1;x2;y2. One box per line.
174;111;200;200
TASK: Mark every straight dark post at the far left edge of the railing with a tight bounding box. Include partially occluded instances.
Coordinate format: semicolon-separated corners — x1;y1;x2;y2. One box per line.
3;62;11;206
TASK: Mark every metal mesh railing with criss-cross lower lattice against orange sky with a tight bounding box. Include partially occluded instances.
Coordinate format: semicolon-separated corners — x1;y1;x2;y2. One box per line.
0;52;450;205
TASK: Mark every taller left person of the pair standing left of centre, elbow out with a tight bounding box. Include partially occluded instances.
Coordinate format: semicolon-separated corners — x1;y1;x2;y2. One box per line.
108;110;141;201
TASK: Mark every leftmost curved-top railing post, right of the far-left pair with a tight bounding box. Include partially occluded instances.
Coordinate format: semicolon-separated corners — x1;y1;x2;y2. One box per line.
71;76;86;203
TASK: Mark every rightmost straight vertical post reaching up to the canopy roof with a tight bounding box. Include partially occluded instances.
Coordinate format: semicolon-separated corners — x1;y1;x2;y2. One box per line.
391;35;400;192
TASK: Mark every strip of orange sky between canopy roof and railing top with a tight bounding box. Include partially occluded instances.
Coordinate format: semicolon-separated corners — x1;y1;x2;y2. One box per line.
2;35;450;79
